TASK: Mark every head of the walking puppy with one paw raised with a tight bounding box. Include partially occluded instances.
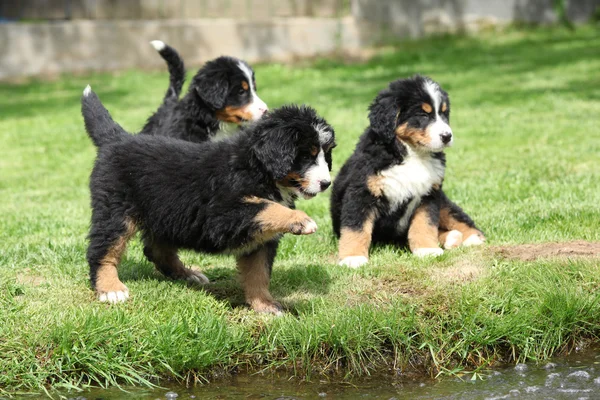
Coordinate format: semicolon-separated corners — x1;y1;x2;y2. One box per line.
252;105;335;199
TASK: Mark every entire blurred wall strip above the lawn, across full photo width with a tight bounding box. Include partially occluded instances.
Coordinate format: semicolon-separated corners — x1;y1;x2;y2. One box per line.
0;0;600;80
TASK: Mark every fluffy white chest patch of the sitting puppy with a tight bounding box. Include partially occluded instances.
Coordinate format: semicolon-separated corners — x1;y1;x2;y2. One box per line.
380;146;444;214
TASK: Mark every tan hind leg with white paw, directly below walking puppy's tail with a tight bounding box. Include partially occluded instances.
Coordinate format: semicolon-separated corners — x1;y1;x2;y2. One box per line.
95;220;135;303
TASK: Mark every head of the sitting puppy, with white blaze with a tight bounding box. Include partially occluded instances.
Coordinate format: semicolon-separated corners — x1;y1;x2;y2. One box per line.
369;75;454;152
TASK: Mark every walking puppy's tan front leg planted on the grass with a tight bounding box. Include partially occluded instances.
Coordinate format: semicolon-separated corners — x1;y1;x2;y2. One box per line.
237;248;282;315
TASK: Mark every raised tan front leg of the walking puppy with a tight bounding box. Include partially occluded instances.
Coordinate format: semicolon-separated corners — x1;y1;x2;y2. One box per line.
246;197;317;241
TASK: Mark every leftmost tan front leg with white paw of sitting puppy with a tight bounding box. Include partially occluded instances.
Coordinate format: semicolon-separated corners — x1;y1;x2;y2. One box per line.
338;213;375;268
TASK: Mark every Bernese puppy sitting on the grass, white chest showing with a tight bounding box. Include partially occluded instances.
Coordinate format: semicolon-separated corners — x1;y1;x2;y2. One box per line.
331;75;485;268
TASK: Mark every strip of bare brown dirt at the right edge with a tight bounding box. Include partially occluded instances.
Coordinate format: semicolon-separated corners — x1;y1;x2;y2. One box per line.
491;240;600;261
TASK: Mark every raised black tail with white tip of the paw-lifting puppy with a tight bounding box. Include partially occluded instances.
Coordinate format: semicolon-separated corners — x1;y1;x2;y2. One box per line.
81;85;129;147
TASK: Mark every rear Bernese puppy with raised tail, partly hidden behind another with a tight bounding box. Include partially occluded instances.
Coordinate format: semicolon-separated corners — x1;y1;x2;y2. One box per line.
140;40;267;143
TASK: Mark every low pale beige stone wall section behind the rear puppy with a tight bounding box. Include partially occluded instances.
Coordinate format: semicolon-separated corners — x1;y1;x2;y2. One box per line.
0;17;368;80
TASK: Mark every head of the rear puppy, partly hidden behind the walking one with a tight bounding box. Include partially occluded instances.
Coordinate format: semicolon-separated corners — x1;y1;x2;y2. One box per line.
190;57;267;124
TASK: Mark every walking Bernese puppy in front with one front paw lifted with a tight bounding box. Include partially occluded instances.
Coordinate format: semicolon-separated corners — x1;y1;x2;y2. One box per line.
82;86;335;314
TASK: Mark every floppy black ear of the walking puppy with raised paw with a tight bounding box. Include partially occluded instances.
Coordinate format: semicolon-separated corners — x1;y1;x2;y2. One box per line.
252;126;298;180
